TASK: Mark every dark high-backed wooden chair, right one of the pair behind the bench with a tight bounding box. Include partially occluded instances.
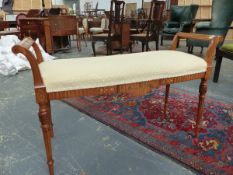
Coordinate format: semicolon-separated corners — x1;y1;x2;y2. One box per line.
130;0;165;52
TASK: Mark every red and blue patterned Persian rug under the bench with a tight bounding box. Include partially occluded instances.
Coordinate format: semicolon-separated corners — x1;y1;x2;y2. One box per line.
65;88;233;175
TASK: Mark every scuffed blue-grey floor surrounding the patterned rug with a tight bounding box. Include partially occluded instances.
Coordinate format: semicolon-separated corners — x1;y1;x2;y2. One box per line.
0;41;233;175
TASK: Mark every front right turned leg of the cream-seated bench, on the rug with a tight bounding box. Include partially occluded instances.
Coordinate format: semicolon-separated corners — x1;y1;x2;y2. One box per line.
195;78;207;138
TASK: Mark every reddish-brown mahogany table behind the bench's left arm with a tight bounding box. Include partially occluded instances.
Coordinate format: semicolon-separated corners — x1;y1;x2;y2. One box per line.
19;16;80;54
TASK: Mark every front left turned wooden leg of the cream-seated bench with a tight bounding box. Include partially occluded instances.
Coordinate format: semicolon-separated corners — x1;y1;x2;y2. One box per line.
38;103;54;175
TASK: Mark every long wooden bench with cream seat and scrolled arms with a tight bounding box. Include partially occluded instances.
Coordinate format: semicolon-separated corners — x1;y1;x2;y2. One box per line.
12;33;221;175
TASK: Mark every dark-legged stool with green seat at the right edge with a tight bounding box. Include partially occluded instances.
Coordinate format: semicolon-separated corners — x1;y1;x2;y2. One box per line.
213;44;233;83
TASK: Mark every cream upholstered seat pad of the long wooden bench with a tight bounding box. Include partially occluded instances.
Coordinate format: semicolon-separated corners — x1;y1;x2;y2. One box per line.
39;51;207;92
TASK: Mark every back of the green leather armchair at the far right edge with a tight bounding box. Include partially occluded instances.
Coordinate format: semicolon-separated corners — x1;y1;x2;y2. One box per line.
211;0;233;29
